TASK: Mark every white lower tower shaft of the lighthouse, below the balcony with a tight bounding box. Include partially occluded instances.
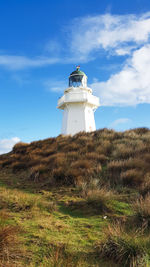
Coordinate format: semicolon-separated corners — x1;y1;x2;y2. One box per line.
62;103;96;135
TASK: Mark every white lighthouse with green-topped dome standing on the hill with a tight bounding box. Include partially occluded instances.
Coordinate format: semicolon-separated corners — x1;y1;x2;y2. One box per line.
57;66;99;135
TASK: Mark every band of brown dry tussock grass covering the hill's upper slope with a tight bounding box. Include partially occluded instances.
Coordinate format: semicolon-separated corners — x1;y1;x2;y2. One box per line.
0;128;150;194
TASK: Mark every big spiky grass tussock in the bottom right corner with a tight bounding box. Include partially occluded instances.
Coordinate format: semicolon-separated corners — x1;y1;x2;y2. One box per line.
96;224;148;267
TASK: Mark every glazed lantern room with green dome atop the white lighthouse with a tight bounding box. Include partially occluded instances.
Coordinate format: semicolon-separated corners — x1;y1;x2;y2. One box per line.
69;66;87;87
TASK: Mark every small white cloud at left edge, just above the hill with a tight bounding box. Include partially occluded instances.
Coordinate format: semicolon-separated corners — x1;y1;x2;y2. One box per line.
0;137;20;154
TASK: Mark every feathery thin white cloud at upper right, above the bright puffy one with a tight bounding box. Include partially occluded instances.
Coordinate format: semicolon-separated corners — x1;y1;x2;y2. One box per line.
70;13;150;57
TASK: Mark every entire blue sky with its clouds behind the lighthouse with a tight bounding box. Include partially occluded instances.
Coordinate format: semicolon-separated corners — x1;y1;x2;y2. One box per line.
0;0;150;153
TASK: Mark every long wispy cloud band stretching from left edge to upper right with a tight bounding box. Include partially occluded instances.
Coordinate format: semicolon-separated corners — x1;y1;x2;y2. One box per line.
0;12;150;70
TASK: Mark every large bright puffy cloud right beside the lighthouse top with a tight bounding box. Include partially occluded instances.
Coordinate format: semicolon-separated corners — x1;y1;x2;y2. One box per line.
91;44;150;106
